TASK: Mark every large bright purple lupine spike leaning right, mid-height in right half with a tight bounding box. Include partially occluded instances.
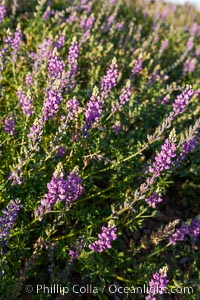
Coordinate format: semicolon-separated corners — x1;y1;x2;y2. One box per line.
149;139;176;177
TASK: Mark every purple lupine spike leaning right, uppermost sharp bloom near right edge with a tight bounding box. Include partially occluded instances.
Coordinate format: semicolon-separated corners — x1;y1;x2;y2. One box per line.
173;85;194;115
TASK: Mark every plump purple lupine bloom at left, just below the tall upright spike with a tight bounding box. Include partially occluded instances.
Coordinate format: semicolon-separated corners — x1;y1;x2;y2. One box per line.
43;90;63;121
